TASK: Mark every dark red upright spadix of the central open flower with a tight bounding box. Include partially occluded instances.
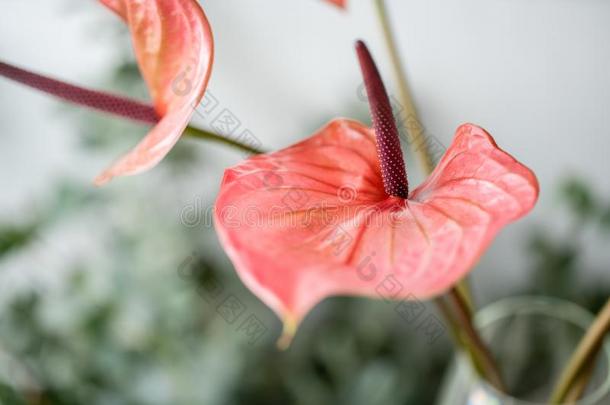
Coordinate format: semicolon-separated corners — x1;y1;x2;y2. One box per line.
356;41;409;198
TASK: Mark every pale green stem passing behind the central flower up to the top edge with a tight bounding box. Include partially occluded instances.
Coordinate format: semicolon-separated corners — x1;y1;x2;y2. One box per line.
374;0;475;317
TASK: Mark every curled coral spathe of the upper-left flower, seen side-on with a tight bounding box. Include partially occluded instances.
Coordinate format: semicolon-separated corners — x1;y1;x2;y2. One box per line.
95;0;214;185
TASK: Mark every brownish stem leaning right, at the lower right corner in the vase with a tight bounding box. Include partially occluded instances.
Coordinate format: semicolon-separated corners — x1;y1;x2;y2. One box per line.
550;299;610;404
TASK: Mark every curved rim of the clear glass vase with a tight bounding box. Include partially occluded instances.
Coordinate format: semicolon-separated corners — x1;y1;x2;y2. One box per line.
474;295;610;405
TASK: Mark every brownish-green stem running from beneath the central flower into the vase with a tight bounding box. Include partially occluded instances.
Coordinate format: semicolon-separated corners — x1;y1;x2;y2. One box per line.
447;288;506;392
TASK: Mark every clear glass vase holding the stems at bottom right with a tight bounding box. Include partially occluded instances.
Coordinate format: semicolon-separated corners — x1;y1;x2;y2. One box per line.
437;297;610;405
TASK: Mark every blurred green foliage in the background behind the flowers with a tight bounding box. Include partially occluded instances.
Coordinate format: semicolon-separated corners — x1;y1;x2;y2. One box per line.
0;165;609;405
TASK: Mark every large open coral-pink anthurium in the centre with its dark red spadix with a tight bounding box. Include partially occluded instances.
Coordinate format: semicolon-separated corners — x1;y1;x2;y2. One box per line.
215;43;538;340
